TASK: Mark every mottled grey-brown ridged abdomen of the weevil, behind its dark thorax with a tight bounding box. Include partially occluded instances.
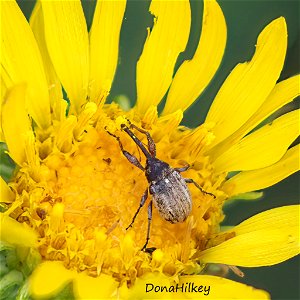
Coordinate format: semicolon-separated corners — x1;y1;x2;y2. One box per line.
150;170;192;223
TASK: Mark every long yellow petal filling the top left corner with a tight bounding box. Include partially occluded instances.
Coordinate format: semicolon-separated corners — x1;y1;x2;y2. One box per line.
1;1;50;128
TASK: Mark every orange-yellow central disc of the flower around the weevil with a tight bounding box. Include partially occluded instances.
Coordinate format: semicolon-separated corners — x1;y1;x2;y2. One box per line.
11;107;225;286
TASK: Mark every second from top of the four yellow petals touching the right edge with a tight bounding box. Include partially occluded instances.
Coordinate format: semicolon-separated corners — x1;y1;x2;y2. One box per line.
214;109;300;172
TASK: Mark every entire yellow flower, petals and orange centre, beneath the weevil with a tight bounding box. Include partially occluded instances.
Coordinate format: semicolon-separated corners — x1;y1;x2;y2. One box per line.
1;0;299;299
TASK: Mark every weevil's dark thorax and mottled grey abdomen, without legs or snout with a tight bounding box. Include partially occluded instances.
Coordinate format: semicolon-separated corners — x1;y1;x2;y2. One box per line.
146;158;192;223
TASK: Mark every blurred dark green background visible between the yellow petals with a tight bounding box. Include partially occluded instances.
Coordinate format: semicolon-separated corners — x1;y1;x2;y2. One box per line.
0;0;300;299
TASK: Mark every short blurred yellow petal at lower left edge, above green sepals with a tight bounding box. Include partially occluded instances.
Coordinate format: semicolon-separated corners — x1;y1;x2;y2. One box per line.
0;213;37;247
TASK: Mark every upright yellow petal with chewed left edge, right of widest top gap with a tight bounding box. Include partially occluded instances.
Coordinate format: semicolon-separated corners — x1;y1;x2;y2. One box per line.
136;0;191;114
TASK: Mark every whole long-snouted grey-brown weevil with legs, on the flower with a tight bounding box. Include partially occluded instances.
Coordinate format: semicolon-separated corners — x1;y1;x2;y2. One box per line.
107;124;215;251
